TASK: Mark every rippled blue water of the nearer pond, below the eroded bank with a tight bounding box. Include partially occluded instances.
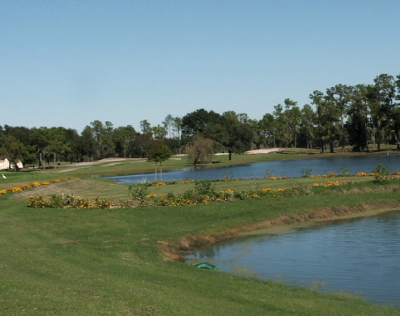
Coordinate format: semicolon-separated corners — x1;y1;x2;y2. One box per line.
188;213;400;308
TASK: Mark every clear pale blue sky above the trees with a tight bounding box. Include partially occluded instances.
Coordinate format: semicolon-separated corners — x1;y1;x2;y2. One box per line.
0;0;400;133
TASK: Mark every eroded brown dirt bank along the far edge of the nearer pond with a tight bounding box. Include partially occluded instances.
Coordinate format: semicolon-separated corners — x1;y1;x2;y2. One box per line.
158;202;400;262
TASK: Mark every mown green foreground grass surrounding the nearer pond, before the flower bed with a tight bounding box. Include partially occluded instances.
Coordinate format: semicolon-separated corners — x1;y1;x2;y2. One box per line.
0;163;400;316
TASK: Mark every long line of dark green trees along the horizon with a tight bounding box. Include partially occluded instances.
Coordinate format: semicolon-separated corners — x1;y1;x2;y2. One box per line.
0;74;400;168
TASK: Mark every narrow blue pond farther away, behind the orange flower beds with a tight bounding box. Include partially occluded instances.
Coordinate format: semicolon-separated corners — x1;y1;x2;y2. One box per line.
107;155;400;183
